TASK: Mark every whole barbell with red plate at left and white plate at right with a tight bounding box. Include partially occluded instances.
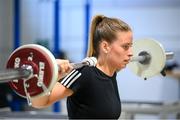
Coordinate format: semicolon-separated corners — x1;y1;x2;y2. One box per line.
0;39;174;105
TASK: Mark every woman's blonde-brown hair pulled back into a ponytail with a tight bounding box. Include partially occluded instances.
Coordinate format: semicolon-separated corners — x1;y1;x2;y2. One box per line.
87;15;131;57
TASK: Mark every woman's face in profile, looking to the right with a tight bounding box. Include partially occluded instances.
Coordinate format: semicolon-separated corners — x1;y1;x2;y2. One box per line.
107;31;133;70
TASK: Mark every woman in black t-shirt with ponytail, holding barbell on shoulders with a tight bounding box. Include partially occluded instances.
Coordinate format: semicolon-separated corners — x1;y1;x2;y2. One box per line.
33;15;133;119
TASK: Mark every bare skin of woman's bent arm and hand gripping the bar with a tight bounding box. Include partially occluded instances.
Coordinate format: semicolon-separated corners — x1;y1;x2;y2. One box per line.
24;59;73;108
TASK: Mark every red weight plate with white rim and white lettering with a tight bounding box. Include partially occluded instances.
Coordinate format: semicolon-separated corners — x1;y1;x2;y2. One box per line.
7;44;57;97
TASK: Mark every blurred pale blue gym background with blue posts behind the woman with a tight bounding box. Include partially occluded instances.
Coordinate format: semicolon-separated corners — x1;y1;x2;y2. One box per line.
0;0;180;119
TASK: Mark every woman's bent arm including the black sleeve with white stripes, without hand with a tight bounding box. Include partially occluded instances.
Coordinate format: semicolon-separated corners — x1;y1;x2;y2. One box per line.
33;70;84;108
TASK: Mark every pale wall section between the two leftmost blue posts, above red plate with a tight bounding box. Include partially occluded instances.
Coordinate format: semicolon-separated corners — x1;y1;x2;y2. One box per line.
21;0;53;48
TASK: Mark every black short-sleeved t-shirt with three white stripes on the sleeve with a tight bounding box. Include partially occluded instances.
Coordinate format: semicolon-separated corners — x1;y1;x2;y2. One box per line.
59;66;121;119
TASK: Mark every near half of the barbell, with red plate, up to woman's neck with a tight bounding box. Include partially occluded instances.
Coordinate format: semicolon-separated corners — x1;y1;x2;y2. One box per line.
0;44;96;105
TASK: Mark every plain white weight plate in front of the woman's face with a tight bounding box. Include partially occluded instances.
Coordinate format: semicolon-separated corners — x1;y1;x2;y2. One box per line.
128;39;166;78
